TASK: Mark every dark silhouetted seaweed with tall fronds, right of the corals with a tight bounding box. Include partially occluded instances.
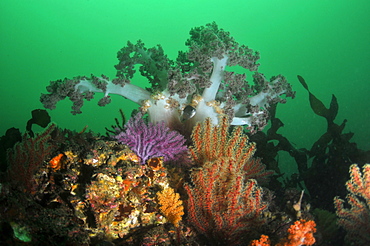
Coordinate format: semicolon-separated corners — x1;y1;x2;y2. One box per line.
250;75;370;211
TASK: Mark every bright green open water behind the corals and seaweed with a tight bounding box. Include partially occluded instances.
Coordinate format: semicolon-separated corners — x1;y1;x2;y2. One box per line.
0;0;370;174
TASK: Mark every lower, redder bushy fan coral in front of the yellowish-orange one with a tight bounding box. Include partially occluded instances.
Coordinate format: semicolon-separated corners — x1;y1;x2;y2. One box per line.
185;158;267;245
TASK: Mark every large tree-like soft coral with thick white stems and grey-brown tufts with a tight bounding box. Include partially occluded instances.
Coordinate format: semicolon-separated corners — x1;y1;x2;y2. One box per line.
40;22;294;135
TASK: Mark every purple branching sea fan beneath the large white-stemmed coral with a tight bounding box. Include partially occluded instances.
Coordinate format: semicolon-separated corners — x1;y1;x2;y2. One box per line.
114;113;188;164
